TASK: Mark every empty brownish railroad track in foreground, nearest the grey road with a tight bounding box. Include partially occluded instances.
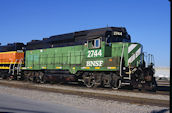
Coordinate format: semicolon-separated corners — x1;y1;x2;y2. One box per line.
0;80;169;107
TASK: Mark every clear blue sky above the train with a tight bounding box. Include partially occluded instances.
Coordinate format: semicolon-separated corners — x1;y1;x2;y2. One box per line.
0;0;170;67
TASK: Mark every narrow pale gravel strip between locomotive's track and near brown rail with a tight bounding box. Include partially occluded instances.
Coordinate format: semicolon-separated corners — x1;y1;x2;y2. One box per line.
0;80;169;101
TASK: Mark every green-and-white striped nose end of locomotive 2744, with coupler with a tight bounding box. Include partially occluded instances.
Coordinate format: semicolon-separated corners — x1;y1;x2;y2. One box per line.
127;43;157;91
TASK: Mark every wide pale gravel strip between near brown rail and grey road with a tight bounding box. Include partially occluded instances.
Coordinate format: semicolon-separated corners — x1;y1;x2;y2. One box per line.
0;86;169;113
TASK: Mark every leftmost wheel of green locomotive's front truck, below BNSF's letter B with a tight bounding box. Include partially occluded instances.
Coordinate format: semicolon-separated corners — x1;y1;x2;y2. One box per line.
83;74;95;88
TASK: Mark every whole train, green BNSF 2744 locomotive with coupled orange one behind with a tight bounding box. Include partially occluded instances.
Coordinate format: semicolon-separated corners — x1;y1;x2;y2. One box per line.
0;27;156;90
